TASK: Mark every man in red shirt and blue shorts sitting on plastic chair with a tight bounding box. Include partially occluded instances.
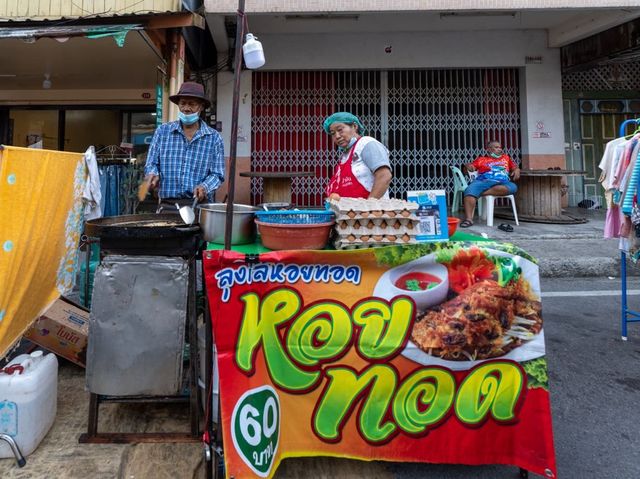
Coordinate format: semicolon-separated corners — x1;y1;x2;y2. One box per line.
460;141;520;228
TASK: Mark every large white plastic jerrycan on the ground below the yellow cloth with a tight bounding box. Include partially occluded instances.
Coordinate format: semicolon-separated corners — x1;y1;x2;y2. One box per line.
0;351;58;458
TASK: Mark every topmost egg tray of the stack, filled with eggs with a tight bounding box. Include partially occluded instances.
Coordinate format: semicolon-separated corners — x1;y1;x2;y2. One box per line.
329;198;418;220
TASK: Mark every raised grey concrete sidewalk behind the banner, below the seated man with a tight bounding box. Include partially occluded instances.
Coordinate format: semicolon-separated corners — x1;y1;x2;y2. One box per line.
458;208;638;278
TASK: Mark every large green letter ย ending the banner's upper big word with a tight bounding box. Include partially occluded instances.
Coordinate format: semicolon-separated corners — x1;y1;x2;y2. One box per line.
353;298;414;360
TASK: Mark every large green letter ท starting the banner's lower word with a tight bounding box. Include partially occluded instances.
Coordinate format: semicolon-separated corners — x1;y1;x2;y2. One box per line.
313;364;398;442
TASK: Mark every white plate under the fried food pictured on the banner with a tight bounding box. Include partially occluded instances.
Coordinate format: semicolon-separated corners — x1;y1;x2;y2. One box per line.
373;249;545;371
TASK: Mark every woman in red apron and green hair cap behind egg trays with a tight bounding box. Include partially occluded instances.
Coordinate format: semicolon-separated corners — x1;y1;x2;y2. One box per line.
323;112;393;198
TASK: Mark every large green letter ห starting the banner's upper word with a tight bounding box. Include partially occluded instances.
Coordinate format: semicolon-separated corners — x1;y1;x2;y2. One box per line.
236;289;320;391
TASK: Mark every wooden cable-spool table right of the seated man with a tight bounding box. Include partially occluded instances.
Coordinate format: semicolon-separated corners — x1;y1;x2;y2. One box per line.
515;170;587;223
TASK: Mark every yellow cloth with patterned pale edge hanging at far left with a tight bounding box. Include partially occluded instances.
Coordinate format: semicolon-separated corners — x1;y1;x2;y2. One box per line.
0;146;87;358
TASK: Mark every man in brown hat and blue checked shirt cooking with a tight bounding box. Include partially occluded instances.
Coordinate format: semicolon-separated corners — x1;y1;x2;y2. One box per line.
144;82;225;211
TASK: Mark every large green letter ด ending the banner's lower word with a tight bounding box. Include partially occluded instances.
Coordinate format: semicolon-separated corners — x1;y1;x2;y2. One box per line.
455;362;524;424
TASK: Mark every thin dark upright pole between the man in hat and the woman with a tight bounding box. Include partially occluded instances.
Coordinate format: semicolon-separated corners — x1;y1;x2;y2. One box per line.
224;0;244;250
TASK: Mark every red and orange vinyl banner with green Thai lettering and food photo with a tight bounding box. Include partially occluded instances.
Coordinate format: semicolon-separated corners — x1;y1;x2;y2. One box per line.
204;242;556;479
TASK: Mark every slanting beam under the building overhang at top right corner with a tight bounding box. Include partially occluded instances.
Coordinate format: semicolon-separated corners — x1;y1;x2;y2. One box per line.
548;8;640;48
